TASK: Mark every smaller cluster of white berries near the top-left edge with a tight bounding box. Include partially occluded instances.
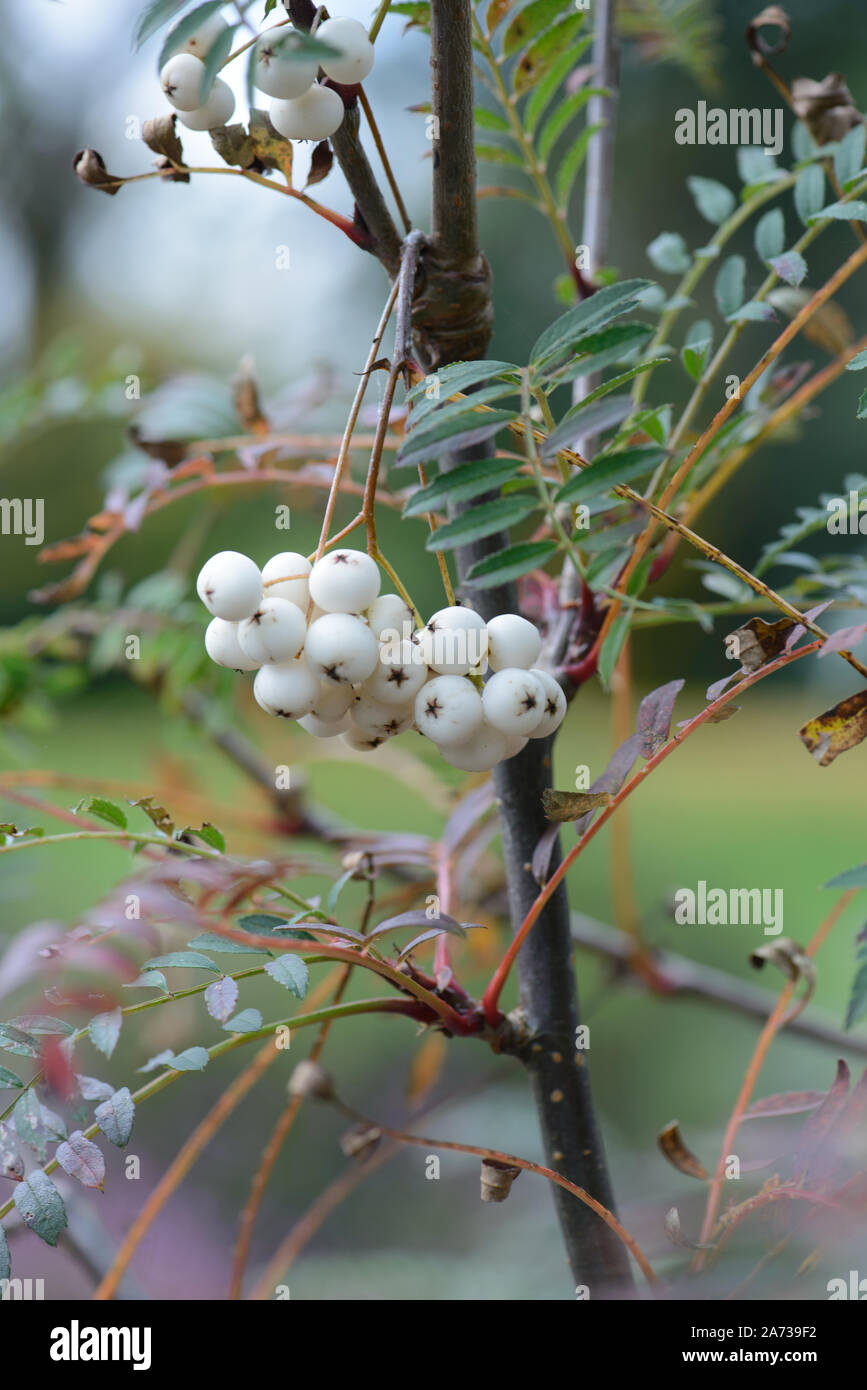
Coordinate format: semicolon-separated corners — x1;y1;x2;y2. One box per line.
160;14;374;140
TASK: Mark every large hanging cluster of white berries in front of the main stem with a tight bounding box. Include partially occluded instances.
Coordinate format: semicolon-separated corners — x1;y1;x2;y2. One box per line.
196;550;565;771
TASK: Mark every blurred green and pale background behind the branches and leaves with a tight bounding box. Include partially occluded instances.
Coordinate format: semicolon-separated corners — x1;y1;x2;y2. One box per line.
0;0;867;1301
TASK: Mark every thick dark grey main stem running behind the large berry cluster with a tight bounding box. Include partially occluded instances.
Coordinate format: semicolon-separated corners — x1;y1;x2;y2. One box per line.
425;0;631;1298
